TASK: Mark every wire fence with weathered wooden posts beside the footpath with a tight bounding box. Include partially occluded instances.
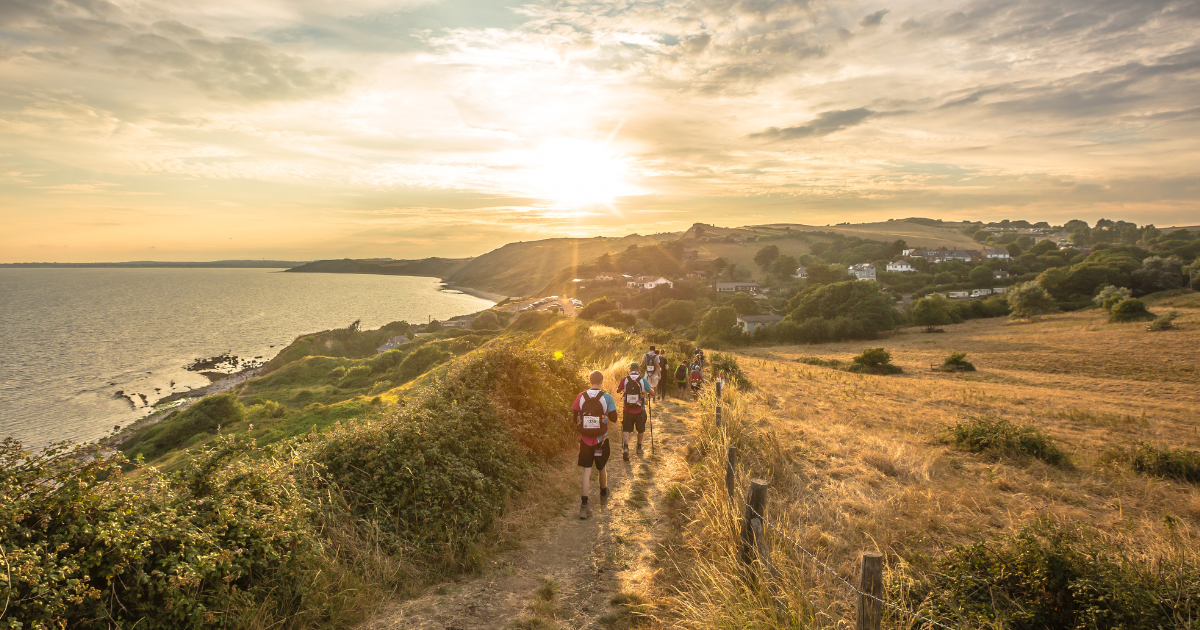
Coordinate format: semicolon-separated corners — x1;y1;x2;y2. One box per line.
714;374;956;630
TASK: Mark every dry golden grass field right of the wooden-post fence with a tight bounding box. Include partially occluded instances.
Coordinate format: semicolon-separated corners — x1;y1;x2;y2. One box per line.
660;294;1200;628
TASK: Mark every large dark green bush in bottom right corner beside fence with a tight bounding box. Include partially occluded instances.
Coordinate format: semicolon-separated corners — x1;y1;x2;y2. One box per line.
911;518;1200;630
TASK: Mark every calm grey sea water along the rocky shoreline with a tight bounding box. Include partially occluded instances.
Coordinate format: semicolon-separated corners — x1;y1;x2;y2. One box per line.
0;269;492;449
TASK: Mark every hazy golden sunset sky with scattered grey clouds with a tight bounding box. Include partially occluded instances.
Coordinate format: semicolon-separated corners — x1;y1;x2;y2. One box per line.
0;0;1200;262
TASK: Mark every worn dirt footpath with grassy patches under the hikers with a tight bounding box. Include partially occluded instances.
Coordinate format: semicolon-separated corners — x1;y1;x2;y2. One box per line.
360;401;694;630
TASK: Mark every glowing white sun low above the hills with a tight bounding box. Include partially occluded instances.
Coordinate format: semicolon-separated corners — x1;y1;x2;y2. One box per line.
529;139;635;209
